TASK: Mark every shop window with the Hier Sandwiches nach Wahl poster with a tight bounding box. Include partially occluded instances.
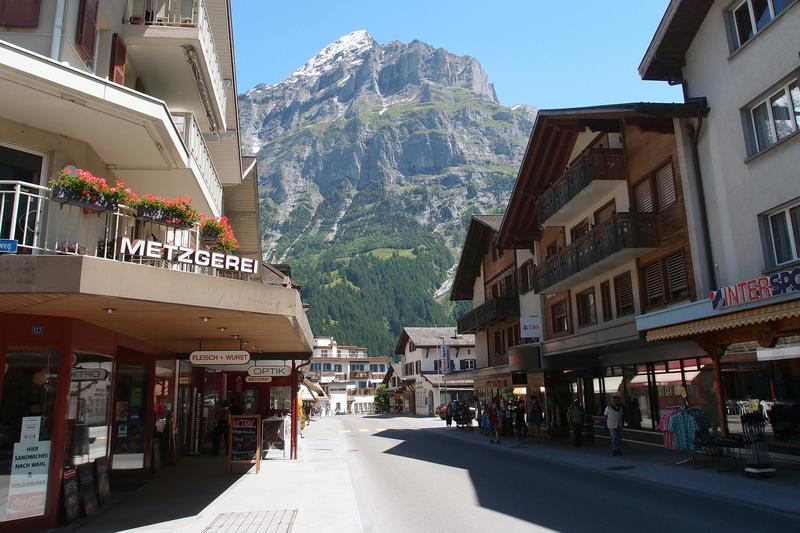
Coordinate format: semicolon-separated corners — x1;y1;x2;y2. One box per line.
0;347;60;522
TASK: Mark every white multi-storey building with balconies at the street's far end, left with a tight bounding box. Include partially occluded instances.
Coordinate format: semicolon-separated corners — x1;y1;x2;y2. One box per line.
306;337;392;415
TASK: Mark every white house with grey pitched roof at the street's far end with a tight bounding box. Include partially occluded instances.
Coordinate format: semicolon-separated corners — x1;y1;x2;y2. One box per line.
394;327;476;416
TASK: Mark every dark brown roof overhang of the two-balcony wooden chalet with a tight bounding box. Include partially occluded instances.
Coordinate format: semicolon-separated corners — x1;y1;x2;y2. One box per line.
497;99;708;249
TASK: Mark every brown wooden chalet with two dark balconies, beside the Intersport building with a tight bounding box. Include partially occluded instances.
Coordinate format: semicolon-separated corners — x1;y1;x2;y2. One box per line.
496;100;716;441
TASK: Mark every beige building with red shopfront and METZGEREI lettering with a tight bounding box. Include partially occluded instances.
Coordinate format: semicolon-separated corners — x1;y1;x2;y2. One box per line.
0;0;313;531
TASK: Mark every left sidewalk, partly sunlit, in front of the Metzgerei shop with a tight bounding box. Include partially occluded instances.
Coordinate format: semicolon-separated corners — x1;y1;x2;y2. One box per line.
54;423;361;533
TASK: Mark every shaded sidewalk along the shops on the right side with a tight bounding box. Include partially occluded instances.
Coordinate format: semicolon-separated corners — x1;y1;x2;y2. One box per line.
405;418;800;515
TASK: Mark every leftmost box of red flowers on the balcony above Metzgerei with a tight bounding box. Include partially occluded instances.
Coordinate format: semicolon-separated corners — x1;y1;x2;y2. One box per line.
50;168;136;212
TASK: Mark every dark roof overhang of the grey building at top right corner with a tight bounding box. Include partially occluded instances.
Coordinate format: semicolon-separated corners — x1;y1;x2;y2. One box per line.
639;0;714;85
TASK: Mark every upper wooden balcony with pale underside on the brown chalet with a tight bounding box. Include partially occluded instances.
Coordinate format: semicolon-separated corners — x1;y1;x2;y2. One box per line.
536;148;627;226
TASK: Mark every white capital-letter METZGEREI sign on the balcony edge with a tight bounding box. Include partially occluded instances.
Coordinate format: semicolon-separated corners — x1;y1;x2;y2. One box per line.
120;237;258;274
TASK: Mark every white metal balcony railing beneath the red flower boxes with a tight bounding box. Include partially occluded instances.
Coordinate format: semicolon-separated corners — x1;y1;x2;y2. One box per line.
0;181;251;280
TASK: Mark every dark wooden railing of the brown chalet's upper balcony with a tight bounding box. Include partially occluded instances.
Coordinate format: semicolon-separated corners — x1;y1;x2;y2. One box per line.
536;148;626;223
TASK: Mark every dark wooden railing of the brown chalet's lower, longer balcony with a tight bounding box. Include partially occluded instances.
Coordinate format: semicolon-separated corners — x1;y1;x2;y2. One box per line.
533;213;658;292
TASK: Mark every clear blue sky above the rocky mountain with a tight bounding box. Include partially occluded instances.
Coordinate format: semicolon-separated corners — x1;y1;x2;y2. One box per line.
233;0;682;108
